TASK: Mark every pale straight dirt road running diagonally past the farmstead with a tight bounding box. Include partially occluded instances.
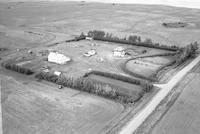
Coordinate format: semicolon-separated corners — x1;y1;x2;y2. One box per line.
120;56;200;134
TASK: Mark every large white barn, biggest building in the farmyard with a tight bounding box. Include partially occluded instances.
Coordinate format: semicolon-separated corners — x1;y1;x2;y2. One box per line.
48;52;71;64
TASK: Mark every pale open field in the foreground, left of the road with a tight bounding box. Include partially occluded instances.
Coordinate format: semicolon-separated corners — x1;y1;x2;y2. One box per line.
1;75;124;134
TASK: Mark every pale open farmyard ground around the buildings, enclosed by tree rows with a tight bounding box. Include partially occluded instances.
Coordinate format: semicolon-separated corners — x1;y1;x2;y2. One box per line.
1;37;177;77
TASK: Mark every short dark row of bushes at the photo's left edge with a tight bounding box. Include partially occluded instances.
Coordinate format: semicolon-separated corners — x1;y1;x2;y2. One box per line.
1;62;34;75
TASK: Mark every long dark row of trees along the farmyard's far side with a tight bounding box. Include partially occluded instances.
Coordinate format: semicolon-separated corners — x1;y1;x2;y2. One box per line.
80;30;180;51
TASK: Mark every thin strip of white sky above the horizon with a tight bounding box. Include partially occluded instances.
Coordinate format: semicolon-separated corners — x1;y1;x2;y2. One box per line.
0;0;200;9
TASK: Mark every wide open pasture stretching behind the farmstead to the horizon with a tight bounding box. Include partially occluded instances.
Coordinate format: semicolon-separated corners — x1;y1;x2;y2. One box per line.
0;1;200;50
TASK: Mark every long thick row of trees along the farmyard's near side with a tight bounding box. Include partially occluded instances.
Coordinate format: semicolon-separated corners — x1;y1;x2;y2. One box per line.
35;72;135;104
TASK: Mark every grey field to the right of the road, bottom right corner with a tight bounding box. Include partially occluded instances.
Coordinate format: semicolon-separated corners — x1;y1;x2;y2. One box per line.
152;66;200;134
